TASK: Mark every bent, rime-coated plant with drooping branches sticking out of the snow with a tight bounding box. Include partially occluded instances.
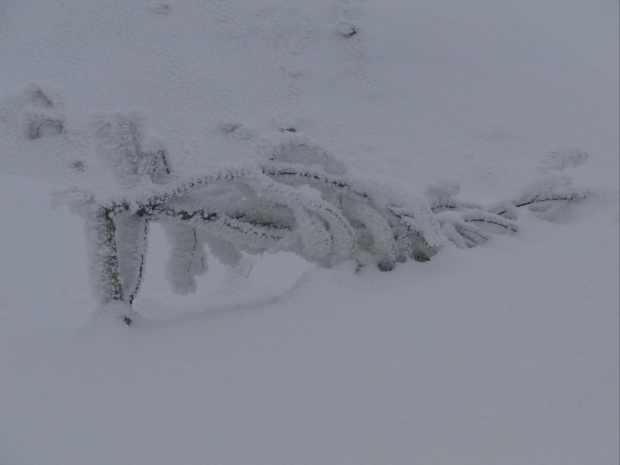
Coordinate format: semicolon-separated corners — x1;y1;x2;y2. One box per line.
59;118;588;324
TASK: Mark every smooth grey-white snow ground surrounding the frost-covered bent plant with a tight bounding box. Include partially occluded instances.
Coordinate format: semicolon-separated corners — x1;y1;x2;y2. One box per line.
0;0;620;465
